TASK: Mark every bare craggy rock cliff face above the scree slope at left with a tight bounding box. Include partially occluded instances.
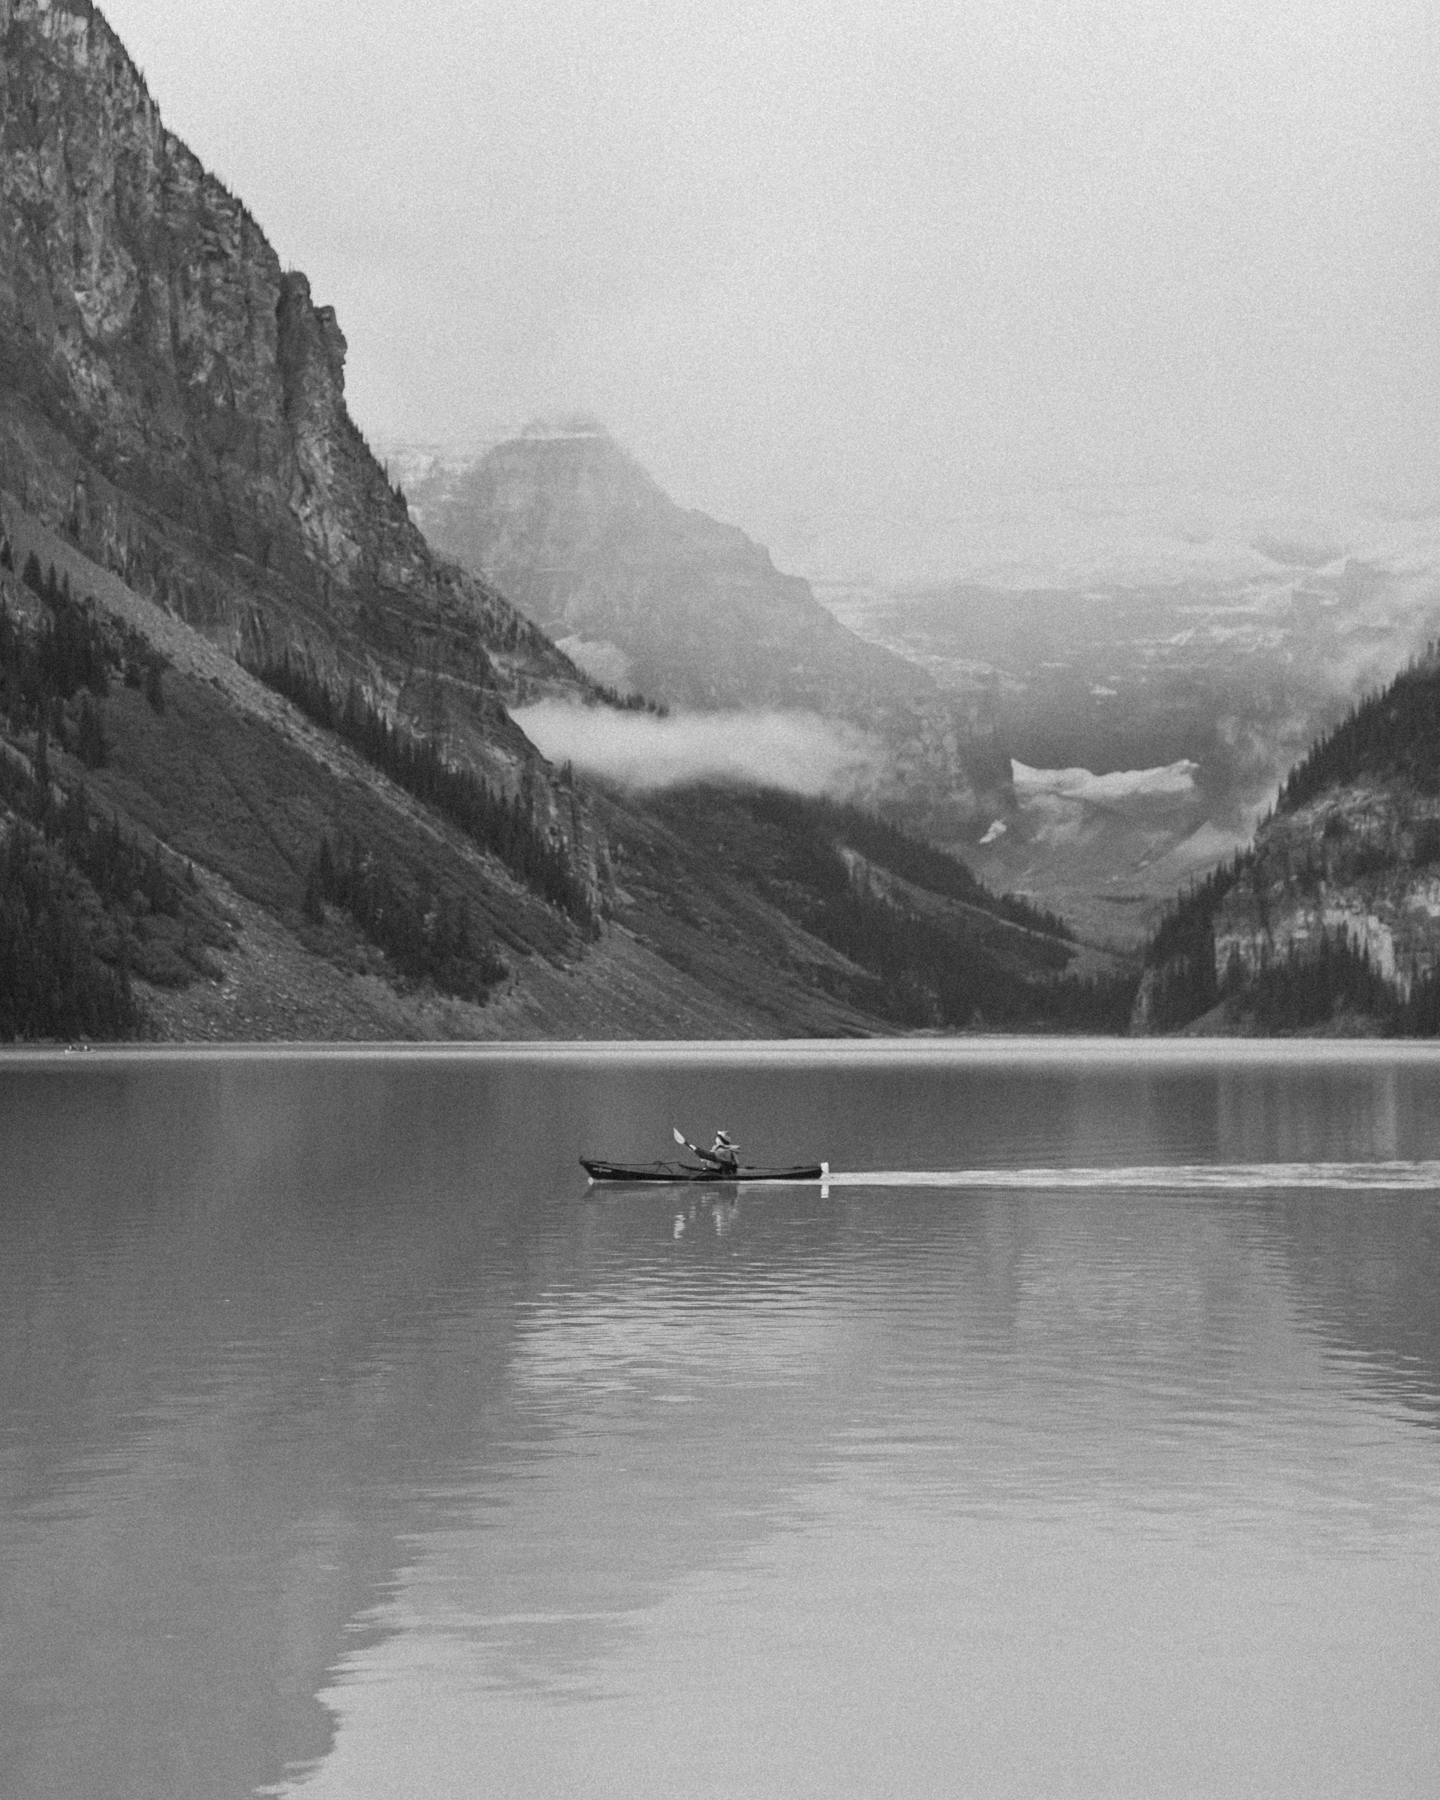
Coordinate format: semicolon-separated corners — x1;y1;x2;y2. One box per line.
0;0;578;795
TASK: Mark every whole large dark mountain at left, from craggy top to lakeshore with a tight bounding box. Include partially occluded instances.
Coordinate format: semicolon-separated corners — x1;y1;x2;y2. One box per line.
0;0;1127;1039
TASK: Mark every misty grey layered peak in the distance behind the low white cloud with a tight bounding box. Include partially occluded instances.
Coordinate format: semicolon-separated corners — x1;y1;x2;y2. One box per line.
391;418;1008;839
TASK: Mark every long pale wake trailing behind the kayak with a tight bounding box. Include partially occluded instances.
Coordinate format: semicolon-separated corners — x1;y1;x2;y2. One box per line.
824;1161;1440;1193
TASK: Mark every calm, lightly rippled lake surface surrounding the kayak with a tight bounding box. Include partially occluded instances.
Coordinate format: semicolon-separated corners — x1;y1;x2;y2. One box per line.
0;1039;1440;1800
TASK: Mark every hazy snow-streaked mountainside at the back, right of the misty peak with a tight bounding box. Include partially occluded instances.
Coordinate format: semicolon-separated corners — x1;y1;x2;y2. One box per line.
819;542;1440;943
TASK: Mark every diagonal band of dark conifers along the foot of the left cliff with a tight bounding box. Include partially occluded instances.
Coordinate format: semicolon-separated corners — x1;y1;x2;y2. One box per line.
252;652;598;932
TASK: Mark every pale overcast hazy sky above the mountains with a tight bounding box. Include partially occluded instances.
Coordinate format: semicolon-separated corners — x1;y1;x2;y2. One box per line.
104;0;1440;536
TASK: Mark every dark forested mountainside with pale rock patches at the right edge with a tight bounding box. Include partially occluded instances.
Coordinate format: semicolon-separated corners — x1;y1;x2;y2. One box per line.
1134;644;1440;1037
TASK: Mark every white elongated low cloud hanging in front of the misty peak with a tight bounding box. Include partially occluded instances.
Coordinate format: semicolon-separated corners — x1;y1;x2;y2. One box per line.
513;700;882;796
